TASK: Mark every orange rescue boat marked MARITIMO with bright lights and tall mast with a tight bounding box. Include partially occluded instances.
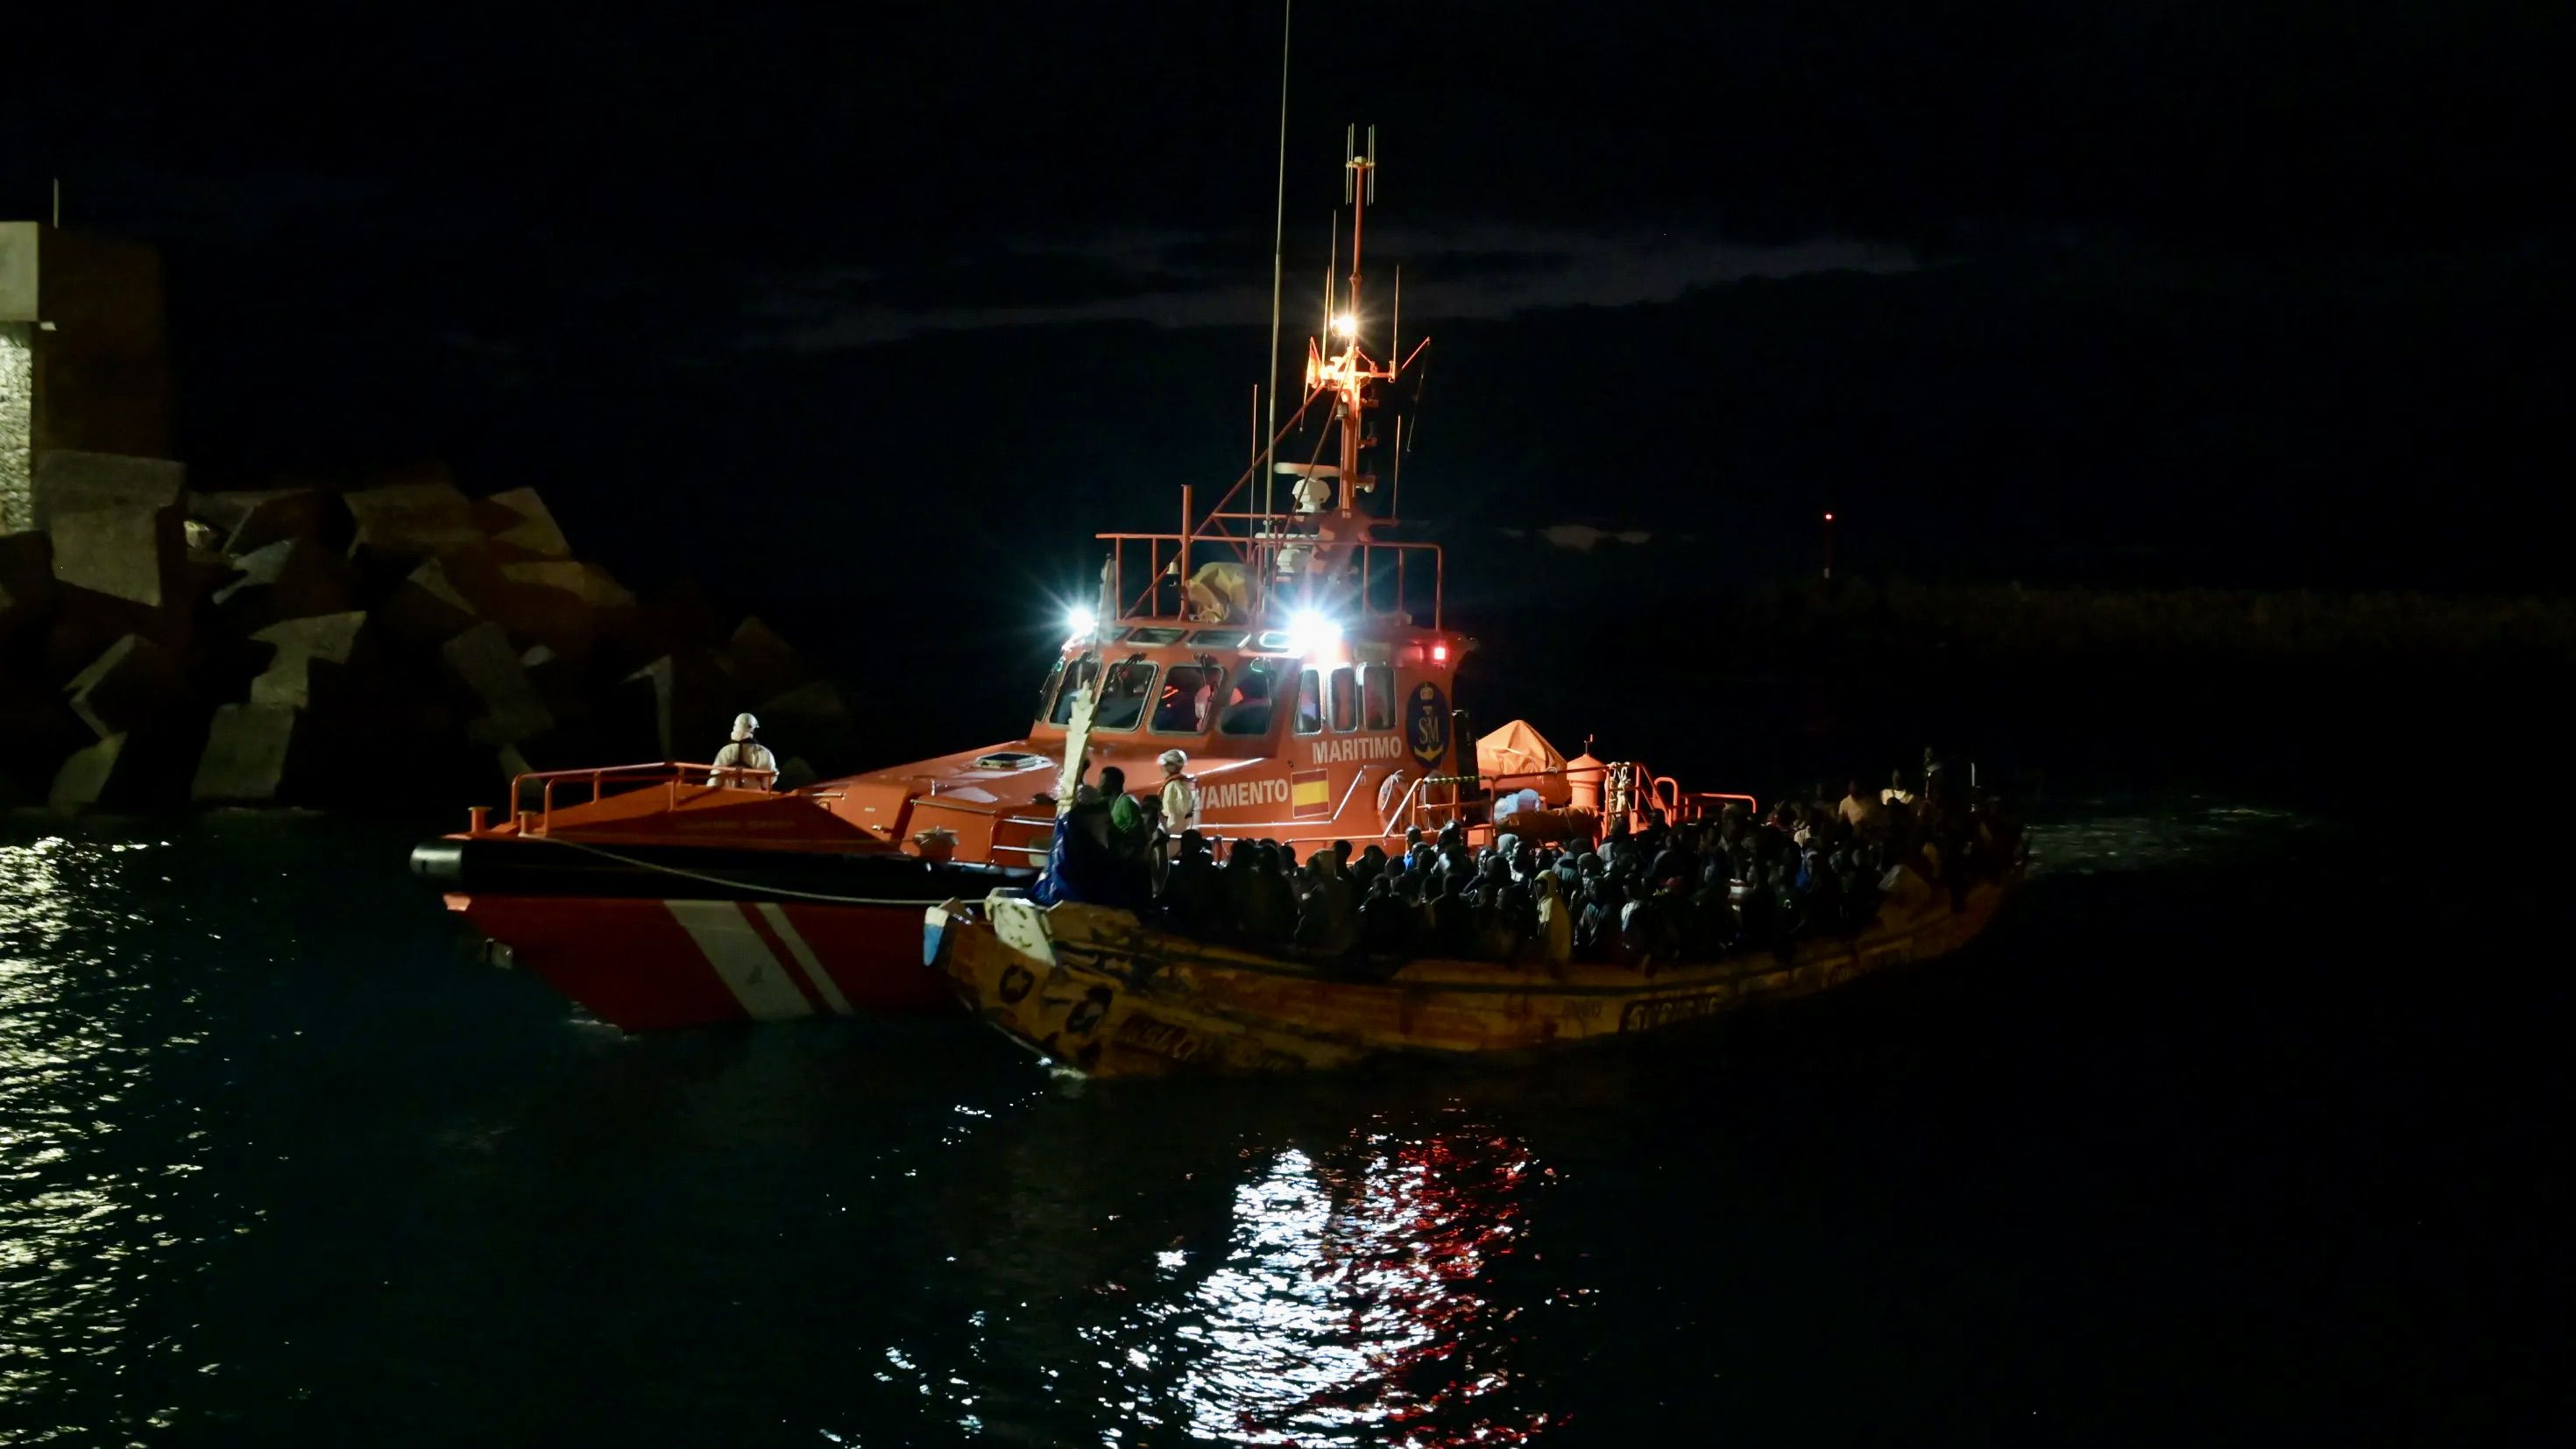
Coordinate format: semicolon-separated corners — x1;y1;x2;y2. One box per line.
412;129;1916;1029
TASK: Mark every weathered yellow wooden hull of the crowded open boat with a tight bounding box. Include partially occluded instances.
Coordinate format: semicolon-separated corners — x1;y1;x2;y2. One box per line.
923;870;2020;1076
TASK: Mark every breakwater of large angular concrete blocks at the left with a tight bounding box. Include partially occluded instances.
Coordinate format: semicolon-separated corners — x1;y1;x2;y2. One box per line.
0;450;860;810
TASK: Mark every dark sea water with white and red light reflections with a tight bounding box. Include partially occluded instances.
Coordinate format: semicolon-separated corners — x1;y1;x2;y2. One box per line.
0;798;2576;1446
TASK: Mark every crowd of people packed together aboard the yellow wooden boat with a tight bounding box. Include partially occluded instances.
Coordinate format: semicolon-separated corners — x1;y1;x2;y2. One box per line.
1038;752;2020;965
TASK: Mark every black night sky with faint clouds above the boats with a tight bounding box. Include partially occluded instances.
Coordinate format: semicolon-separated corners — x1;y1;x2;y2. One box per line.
0;0;2576;675
